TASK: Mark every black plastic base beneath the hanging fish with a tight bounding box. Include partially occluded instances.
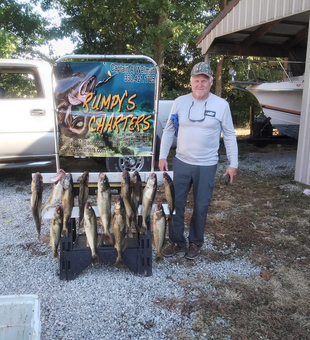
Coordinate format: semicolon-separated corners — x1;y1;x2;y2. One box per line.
60;216;152;280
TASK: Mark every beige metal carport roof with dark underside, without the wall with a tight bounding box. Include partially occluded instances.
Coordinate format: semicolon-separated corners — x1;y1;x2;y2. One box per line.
196;0;310;57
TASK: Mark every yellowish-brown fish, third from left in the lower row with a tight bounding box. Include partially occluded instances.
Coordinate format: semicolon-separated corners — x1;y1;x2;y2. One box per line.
113;196;127;267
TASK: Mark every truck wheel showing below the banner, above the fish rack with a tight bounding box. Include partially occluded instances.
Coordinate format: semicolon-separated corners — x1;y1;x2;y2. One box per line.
106;156;152;172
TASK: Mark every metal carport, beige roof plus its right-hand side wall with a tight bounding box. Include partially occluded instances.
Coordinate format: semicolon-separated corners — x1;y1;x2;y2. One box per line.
196;0;310;185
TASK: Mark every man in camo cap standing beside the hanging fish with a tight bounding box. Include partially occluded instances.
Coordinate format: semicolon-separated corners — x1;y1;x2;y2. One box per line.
158;62;238;260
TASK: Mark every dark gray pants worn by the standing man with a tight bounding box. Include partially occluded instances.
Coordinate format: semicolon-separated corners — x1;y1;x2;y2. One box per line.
169;157;217;247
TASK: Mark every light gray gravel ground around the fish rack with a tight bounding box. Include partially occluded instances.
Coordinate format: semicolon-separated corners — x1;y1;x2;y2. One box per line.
0;146;296;340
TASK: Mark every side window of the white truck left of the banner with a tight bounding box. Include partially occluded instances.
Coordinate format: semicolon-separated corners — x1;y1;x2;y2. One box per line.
0;68;44;100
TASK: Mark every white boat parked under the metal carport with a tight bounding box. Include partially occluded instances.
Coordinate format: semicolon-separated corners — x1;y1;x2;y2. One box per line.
230;60;304;139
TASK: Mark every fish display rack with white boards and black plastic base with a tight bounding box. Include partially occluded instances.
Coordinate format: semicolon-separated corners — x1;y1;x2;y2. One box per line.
37;171;172;280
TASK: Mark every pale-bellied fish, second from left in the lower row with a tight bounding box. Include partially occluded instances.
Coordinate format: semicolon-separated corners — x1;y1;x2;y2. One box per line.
84;202;98;264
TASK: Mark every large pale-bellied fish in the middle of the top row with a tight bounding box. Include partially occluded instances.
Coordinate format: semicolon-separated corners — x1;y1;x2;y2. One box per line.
97;172;113;244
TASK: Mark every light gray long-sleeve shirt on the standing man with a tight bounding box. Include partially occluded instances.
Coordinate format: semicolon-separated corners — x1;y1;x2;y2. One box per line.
159;93;238;168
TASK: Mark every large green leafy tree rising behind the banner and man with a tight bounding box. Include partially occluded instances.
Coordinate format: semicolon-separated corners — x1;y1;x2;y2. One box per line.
41;0;217;98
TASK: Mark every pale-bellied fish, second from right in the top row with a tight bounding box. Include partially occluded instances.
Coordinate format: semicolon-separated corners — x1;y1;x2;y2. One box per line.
141;172;157;234
